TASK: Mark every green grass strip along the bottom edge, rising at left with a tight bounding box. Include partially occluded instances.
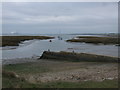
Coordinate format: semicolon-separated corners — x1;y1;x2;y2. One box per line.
2;76;118;88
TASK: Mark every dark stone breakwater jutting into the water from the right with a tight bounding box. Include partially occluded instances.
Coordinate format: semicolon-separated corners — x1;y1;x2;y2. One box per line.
39;51;118;62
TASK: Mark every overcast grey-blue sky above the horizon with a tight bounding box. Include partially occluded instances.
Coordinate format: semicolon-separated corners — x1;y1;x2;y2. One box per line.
2;2;118;34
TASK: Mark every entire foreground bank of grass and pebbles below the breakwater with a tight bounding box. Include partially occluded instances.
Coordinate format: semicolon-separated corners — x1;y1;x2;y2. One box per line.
2;60;118;88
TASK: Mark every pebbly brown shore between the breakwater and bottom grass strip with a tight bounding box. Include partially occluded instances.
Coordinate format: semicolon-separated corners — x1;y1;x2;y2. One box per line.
3;59;118;87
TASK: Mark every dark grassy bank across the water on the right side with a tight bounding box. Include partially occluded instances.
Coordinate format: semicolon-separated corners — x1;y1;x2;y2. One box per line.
67;36;120;45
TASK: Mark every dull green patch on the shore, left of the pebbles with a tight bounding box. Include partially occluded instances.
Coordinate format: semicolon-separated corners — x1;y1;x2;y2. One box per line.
3;63;50;75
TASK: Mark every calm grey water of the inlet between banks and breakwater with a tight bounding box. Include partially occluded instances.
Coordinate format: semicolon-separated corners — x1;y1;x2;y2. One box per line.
2;35;118;59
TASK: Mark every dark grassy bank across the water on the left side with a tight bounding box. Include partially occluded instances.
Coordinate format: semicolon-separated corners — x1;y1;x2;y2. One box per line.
0;36;54;47
